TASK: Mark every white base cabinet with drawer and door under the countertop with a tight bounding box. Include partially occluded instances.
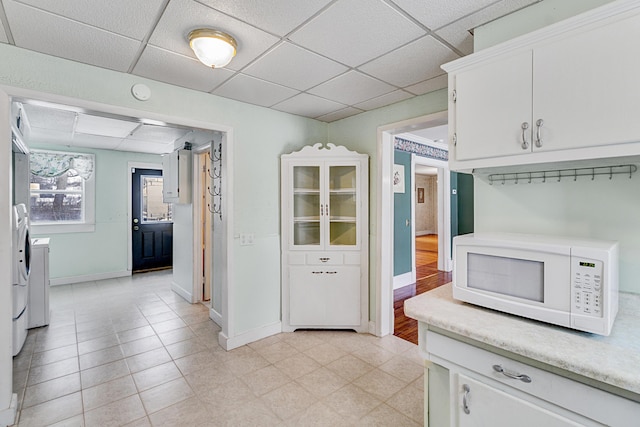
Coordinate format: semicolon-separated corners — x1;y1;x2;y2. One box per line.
419;332;640;427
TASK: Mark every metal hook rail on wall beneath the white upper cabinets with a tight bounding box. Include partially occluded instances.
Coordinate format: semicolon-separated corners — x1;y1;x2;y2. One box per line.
488;165;638;185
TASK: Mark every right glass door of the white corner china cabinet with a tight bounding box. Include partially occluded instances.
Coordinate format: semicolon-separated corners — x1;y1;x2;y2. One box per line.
329;165;358;246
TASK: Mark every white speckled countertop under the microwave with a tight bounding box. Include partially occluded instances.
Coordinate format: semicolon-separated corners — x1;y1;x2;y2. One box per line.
404;283;640;394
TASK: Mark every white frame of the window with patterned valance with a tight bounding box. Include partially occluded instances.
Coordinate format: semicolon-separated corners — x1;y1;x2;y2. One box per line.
29;149;97;234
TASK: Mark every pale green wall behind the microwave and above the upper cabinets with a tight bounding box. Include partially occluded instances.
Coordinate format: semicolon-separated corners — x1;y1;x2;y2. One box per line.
475;0;640;293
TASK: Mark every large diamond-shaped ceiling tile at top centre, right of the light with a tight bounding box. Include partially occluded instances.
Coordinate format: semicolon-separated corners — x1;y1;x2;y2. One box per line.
289;0;425;67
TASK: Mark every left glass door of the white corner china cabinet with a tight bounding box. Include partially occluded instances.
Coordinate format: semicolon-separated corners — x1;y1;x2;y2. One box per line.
293;166;322;246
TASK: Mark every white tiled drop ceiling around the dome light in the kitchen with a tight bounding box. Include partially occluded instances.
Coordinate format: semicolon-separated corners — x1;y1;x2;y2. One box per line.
0;0;539;122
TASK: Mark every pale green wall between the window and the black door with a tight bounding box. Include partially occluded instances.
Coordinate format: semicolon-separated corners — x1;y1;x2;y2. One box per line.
31;144;162;279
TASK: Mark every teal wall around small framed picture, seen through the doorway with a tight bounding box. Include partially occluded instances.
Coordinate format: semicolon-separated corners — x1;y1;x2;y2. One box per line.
393;150;413;276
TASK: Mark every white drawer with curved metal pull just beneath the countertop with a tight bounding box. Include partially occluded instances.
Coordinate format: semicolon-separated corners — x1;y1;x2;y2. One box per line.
424;331;640;426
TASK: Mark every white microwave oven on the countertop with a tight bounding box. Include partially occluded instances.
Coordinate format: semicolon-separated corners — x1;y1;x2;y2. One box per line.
453;233;618;335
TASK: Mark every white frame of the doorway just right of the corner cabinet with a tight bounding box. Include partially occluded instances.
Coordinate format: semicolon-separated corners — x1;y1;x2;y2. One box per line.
376;110;451;337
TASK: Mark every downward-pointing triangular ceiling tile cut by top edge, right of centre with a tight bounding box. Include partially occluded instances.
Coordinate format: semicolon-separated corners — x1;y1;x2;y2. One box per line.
393;0;496;30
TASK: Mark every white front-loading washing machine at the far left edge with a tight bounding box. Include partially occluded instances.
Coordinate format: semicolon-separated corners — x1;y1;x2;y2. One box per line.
12;203;31;356
